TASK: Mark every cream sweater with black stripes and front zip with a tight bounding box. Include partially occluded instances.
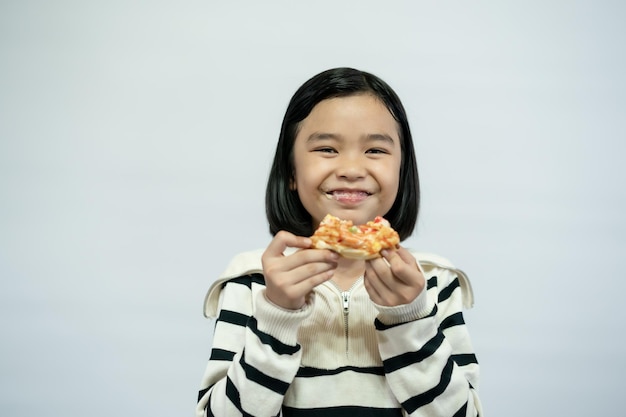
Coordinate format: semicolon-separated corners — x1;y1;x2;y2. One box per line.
196;251;482;417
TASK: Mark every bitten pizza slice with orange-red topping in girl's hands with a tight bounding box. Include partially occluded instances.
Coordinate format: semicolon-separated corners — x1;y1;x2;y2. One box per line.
311;214;400;259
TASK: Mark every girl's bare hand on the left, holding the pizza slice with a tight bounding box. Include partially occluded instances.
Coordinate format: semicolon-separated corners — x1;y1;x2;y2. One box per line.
261;231;339;310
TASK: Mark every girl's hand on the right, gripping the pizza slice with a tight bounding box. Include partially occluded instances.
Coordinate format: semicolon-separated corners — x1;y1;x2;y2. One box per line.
364;247;426;306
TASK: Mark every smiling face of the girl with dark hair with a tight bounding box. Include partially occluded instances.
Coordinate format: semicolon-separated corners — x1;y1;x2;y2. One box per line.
292;94;402;225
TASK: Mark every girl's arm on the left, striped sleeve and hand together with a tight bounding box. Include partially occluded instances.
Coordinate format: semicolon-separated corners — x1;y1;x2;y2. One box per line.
196;232;336;417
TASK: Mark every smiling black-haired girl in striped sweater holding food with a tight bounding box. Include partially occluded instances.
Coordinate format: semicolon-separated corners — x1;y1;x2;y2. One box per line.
196;68;481;417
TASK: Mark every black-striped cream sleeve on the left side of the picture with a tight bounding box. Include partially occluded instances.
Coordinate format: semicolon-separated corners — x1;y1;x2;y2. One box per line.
196;279;313;417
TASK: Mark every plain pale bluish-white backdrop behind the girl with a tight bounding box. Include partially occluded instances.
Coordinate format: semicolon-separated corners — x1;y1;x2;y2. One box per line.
0;0;626;417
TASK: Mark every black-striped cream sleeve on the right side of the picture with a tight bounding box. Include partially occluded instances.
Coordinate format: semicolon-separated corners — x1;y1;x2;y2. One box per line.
376;269;482;417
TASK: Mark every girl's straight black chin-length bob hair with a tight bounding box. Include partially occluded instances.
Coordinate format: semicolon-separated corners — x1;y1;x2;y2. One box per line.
265;68;420;240
